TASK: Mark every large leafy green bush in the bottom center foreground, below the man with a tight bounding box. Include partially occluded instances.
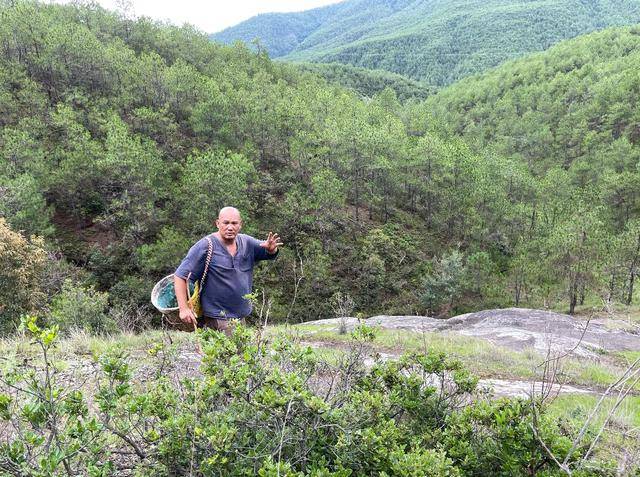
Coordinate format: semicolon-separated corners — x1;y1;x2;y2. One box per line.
95;327;592;476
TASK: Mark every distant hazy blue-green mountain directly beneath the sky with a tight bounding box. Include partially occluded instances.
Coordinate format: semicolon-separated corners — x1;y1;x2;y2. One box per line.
211;0;640;86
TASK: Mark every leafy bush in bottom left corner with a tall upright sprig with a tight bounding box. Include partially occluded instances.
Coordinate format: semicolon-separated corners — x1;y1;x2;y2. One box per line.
0;316;114;477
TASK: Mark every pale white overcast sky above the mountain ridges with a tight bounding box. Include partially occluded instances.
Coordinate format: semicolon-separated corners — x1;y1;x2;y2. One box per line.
53;0;340;33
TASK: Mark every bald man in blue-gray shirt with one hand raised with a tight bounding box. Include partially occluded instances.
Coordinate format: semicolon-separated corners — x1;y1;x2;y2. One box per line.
174;207;282;332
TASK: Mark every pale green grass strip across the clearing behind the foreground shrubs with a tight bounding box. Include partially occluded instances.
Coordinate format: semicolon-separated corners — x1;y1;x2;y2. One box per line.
0;308;640;392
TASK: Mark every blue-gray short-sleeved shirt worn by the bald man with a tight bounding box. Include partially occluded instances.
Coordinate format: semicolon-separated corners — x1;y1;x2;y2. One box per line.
175;234;278;319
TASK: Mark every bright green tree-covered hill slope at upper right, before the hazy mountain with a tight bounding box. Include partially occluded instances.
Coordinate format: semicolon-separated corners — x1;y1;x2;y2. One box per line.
424;26;640;178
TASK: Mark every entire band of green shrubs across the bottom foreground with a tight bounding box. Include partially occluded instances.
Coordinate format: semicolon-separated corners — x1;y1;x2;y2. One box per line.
0;319;632;477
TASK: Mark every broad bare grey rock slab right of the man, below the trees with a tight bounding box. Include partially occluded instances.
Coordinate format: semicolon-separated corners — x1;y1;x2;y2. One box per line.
301;308;640;357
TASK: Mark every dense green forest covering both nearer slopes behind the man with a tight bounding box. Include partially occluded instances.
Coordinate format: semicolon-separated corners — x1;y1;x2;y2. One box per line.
0;1;640;331
